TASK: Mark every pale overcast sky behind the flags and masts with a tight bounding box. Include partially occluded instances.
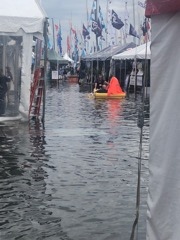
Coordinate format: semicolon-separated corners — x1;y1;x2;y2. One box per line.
40;0;144;52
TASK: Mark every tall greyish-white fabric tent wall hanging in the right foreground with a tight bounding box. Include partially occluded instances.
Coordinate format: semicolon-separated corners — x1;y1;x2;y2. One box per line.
146;12;180;240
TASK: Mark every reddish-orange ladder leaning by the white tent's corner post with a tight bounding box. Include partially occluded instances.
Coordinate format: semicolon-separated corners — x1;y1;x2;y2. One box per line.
29;68;44;119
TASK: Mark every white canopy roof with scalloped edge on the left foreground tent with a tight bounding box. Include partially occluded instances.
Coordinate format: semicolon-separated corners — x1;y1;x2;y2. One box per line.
0;0;46;33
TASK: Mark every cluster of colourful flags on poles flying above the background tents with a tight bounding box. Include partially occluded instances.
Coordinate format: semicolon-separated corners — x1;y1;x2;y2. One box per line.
48;0;148;57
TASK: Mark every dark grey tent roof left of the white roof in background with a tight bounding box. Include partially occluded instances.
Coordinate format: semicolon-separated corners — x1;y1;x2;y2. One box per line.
83;42;136;61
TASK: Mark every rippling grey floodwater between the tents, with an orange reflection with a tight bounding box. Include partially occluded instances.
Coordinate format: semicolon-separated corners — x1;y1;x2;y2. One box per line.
0;83;149;240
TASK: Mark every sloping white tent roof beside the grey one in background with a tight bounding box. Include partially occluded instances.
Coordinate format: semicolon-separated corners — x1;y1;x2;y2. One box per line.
112;42;151;60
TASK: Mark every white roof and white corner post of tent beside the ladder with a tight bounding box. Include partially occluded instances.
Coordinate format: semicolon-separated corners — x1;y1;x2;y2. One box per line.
0;0;46;120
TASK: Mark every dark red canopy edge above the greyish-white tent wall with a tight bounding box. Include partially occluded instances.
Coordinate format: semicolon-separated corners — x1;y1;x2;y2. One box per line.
145;0;180;17
